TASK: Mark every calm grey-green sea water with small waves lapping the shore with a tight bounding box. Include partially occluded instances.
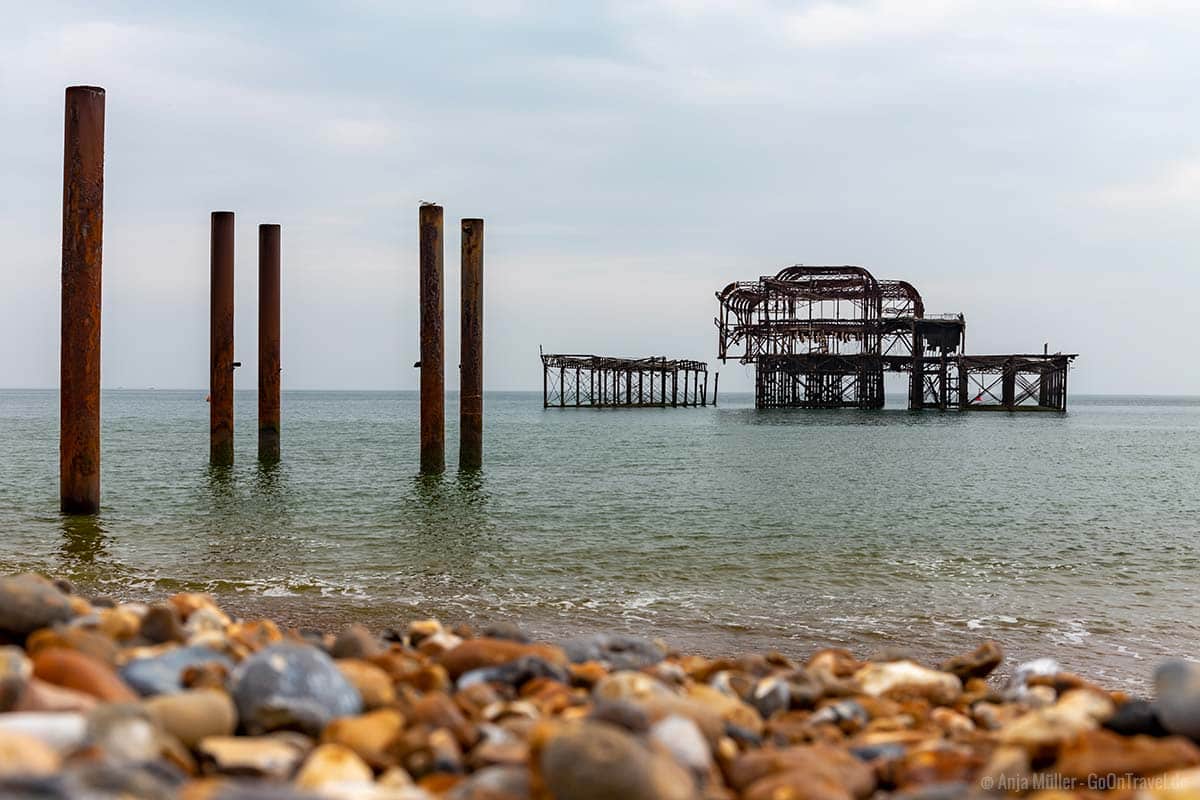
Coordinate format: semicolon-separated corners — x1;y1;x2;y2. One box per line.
0;391;1200;687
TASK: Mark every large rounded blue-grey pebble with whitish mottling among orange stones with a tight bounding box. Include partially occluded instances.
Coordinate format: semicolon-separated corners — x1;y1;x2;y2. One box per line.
230;644;362;735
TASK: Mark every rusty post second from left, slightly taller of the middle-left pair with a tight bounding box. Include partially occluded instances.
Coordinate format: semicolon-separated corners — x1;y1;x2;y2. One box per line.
209;211;234;467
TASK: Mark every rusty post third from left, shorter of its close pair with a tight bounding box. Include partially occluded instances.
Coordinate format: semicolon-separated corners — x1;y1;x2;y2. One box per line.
258;224;280;463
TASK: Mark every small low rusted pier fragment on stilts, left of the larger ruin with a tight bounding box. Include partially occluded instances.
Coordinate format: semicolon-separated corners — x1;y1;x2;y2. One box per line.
541;353;715;408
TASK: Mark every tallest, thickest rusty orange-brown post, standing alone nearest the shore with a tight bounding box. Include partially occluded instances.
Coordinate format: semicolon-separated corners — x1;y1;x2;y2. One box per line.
59;86;104;513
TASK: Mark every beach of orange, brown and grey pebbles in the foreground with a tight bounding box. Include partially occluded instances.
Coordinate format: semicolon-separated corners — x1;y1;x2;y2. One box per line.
0;573;1200;800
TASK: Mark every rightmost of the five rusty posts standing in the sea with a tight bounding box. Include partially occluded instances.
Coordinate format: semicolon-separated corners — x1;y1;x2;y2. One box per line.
458;219;482;470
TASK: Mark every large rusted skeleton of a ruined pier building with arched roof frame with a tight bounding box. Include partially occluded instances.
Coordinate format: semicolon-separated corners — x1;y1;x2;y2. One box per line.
714;265;1075;411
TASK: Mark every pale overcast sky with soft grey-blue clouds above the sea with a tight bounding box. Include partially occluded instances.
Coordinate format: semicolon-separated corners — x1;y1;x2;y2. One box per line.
0;0;1200;395
